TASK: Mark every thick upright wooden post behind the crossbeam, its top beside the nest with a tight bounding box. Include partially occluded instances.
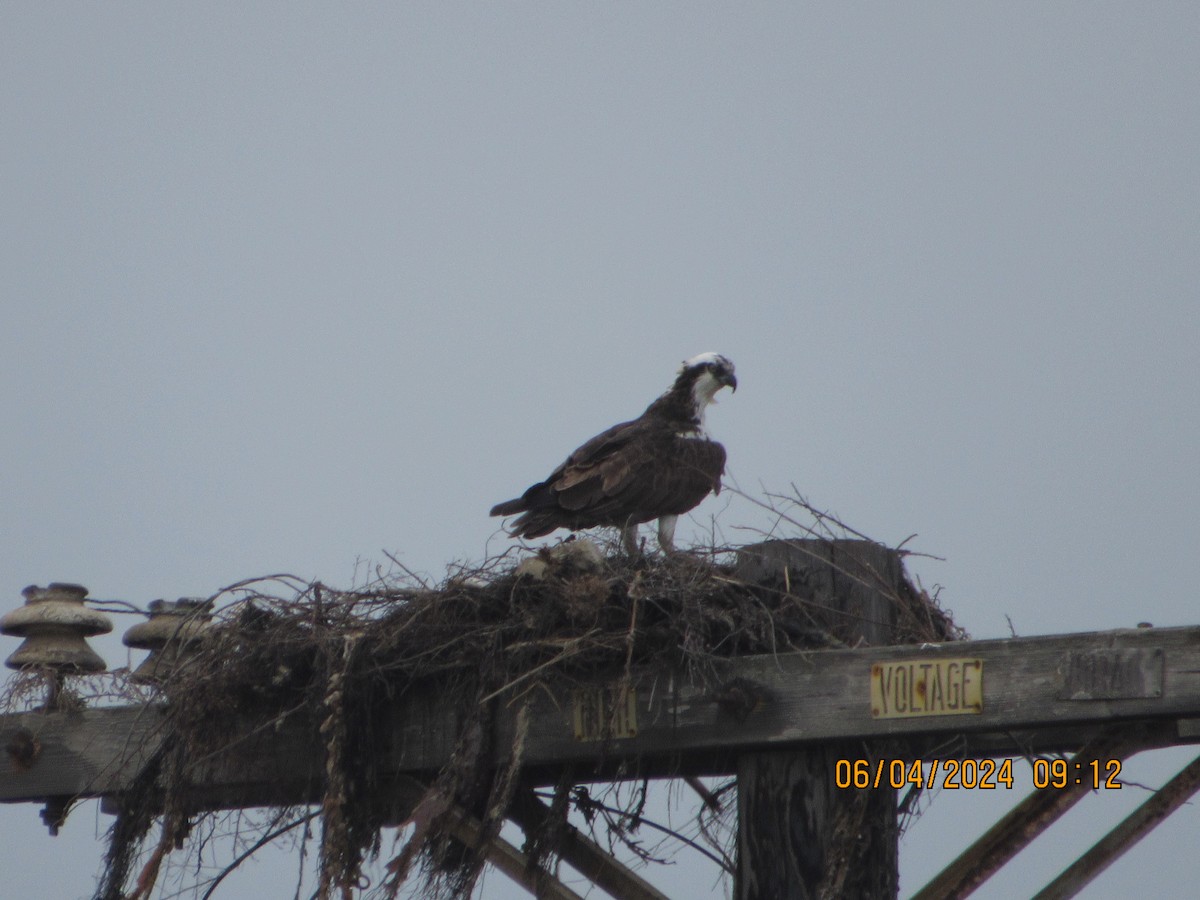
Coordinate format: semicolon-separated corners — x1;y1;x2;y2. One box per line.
734;540;902;900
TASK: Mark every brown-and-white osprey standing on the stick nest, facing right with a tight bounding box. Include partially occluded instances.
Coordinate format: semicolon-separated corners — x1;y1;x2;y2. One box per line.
491;353;738;554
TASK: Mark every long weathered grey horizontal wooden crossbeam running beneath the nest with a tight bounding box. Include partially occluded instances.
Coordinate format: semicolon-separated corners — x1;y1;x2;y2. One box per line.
0;626;1200;805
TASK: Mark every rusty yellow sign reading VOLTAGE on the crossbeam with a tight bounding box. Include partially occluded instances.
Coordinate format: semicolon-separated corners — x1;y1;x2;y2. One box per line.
871;658;983;719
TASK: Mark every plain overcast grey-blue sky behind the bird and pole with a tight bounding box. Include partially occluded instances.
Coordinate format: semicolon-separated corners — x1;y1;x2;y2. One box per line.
0;2;1200;898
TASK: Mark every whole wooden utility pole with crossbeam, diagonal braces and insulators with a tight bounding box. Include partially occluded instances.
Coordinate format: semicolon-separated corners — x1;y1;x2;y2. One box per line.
0;540;1200;900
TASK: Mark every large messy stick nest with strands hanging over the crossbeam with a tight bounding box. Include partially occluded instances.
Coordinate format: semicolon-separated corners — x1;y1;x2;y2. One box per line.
11;528;965;900
